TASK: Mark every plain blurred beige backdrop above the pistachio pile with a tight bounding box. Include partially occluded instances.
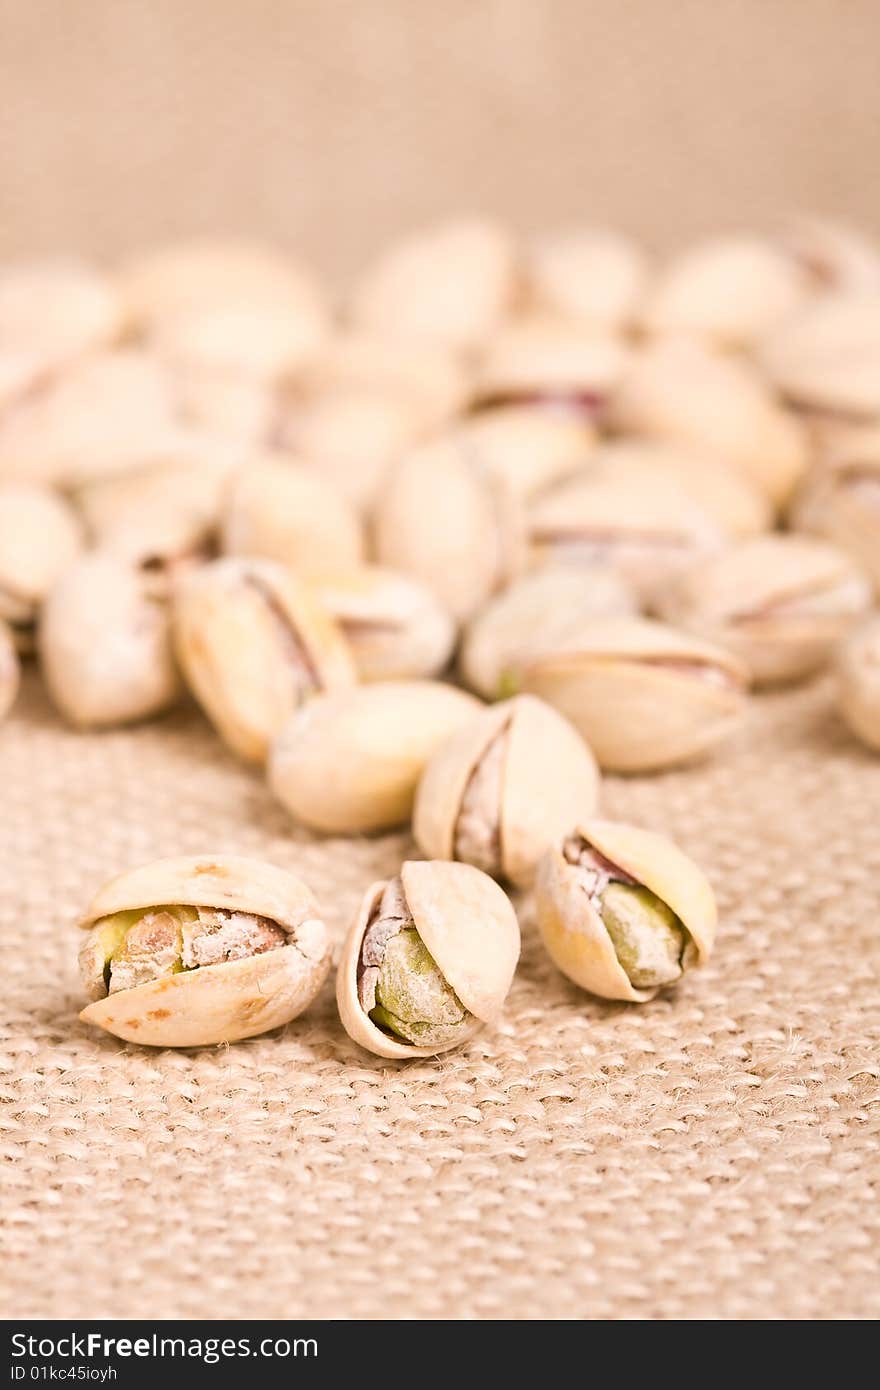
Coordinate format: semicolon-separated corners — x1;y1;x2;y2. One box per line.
0;0;880;275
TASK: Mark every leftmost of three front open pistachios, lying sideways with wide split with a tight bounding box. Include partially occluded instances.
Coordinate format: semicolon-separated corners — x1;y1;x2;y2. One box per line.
79;855;331;1047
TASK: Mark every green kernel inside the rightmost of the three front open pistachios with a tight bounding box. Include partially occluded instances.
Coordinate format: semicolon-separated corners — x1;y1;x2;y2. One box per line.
601;881;690;990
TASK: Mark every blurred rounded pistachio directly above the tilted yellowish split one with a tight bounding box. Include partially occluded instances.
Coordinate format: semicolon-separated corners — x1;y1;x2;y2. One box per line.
222;457;364;580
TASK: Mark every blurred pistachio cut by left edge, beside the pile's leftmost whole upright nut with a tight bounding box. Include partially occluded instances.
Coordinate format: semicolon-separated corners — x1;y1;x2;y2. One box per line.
0;482;82;652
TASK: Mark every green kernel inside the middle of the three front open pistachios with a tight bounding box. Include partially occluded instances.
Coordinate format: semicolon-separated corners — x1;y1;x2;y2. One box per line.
370;927;471;1047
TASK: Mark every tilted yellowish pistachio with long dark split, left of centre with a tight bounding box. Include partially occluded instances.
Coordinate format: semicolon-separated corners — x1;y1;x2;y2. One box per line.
172;559;356;762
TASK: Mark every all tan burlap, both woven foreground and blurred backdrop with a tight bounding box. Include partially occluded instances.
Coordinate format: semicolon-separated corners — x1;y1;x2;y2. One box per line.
0;0;880;1318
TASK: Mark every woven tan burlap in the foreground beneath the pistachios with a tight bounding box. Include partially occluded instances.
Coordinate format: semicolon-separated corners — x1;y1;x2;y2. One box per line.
0;677;880;1319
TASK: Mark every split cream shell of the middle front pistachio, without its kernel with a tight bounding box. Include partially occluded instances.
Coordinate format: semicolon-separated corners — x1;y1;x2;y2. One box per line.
336;860;520;1059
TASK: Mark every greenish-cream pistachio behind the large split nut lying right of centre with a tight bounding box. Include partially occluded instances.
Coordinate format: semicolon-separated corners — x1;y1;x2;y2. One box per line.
459;566;638;699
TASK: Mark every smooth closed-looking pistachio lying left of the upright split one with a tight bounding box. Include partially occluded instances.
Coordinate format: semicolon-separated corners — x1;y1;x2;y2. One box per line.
268;681;480;834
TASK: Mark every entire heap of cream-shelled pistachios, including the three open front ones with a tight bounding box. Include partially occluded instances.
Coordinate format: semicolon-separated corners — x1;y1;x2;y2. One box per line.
0;218;880;1058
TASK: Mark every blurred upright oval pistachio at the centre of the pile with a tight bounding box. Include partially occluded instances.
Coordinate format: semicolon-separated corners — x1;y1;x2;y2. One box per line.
375;436;523;621
